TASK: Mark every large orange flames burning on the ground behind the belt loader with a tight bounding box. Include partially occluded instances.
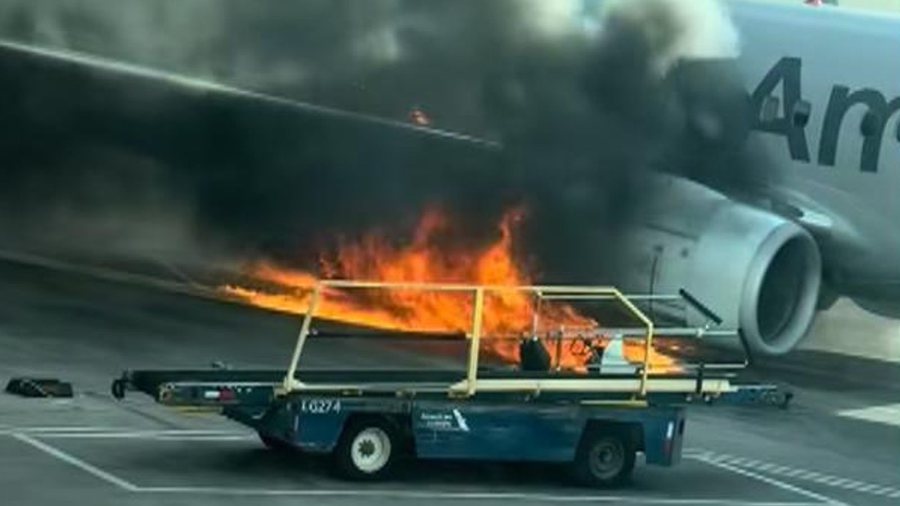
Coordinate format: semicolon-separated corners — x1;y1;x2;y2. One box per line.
224;209;671;370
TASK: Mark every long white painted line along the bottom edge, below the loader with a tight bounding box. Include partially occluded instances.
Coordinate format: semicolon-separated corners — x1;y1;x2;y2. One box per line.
138;487;825;506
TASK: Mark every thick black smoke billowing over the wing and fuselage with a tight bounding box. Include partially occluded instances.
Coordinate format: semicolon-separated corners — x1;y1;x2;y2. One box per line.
0;0;757;280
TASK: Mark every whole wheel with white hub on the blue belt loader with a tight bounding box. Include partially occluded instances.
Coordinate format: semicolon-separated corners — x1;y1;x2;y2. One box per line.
334;418;400;480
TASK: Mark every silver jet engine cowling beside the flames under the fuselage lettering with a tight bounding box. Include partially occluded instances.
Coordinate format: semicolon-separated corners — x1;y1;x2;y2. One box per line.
625;177;822;355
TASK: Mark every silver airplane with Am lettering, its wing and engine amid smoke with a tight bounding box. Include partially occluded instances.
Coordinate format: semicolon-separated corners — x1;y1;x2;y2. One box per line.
0;0;900;356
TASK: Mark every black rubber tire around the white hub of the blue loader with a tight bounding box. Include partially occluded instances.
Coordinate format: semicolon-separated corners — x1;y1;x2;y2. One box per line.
332;417;403;481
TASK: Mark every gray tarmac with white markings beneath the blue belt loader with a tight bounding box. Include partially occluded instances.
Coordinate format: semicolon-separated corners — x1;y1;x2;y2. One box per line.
0;262;900;506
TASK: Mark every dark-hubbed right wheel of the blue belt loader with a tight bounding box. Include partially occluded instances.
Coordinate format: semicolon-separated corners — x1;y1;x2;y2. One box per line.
574;429;635;487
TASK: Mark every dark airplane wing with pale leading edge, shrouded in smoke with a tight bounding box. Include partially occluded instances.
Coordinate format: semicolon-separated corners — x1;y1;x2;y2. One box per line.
0;41;500;253
